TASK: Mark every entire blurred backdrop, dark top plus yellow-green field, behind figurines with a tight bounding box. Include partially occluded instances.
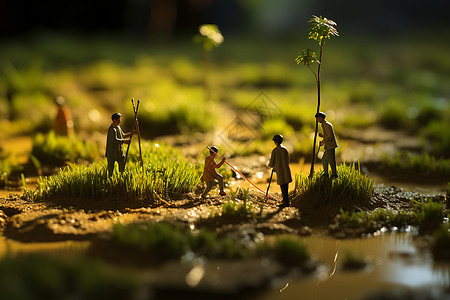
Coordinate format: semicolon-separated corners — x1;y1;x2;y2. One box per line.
0;0;450;180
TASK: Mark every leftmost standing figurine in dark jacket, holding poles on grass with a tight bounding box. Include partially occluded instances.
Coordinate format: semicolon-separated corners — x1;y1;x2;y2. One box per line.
105;113;130;176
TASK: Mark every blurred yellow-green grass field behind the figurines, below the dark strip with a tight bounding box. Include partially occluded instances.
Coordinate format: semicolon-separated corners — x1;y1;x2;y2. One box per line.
0;34;450;157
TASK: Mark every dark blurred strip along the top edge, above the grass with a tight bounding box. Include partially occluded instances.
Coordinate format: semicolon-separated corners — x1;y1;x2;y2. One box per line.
0;0;449;39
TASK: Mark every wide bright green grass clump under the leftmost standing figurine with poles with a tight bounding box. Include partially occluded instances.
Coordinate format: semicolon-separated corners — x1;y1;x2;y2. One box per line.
24;143;200;204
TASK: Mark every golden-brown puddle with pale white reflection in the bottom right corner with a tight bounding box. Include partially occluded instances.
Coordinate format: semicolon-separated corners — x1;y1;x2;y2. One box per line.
257;231;450;300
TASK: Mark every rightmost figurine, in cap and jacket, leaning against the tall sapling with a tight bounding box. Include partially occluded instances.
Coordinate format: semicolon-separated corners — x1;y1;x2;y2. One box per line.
315;112;338;179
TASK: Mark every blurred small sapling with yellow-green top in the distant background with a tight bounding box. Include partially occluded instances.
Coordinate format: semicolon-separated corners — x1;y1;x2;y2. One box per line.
194;24;223;100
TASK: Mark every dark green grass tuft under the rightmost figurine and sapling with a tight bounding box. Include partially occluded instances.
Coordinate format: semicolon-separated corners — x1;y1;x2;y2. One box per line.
294;164;373;205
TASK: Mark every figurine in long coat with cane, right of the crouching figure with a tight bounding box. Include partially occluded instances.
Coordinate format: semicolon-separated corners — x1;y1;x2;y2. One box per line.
269;134;292;208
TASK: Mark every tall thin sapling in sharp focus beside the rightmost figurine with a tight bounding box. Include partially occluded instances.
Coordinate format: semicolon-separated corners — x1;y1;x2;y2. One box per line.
295;16;339;177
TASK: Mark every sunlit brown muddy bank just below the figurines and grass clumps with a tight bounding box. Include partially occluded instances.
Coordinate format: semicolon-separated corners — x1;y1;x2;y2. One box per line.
0;186;444;242
